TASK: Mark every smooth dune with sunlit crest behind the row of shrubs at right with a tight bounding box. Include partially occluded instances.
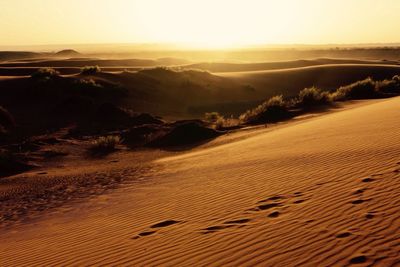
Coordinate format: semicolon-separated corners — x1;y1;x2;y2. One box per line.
218;64;400;96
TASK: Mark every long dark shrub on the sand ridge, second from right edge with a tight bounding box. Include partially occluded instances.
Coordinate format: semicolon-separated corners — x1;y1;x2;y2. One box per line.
332;78;380;101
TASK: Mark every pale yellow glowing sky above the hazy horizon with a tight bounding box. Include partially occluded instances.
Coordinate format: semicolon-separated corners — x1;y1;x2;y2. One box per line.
0;0;400;48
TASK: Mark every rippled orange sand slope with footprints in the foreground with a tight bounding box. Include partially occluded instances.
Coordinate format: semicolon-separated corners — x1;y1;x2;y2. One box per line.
0;98;400;266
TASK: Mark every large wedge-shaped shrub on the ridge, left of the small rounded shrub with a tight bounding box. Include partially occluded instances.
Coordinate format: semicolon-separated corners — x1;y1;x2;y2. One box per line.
239;95;290;124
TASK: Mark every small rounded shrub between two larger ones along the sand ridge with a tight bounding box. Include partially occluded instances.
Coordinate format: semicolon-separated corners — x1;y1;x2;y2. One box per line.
295;87;331;108
